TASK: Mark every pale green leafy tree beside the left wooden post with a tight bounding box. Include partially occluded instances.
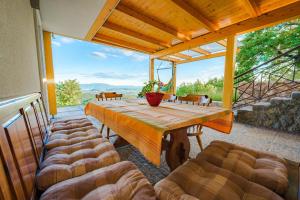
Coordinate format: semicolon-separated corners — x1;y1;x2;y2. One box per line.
56;79;82;106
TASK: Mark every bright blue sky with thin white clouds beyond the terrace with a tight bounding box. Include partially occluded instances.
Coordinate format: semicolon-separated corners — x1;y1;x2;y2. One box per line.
52;35;224;86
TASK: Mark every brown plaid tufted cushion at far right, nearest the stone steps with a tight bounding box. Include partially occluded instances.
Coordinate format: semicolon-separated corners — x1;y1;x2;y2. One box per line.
201;141;288;194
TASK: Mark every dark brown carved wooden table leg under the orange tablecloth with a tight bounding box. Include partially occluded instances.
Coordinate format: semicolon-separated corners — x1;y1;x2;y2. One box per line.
166;128;190;171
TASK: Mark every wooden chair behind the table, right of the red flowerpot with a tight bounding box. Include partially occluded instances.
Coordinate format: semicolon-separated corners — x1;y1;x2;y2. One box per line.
178;95;212;151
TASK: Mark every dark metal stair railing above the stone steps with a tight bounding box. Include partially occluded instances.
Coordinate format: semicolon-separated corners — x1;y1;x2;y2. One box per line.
233;45;300;108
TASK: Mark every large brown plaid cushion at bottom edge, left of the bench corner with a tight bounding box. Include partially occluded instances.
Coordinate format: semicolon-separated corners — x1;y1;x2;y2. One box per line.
41;161;156;200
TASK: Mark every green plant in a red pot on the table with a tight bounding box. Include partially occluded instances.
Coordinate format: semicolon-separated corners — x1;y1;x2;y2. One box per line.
138;81;164;107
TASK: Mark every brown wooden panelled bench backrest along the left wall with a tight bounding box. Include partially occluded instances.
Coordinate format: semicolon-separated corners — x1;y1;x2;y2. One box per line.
0;93;48;199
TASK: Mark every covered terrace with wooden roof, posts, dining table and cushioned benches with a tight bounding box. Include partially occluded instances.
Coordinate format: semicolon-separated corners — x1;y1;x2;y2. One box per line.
0;0;300;200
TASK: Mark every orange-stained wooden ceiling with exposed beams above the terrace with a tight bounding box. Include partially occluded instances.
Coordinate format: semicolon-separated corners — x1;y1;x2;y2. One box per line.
86;0;300;63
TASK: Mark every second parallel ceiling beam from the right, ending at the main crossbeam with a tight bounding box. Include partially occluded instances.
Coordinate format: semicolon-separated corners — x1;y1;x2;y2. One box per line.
172;0;219;31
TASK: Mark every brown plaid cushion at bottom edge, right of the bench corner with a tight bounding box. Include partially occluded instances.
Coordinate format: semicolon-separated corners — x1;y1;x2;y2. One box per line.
154;157;283;200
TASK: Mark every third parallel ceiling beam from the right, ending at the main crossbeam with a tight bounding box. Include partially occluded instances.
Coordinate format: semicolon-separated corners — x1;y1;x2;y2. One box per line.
116;4;191;41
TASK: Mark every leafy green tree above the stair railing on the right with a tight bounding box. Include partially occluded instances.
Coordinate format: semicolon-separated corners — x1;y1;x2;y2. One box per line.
235;19;300;75
